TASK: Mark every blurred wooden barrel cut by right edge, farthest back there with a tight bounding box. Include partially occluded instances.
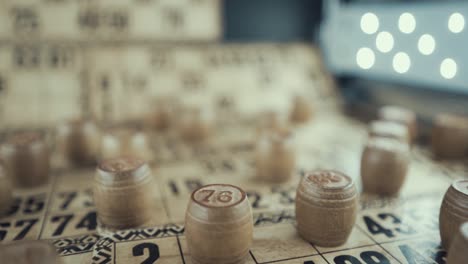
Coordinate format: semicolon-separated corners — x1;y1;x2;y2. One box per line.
431;114;468;159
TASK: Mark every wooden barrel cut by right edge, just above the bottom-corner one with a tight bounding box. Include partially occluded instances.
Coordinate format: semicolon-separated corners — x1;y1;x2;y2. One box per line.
439;180;468;250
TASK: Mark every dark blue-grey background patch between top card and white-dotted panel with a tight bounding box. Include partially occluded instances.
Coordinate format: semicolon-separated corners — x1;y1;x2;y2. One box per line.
223;0;322;42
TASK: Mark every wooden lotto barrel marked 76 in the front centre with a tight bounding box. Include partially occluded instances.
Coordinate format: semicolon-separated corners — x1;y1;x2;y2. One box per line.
185;184;253;264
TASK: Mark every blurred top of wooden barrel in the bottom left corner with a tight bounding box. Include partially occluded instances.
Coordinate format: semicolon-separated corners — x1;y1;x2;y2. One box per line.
0;240;62;264
